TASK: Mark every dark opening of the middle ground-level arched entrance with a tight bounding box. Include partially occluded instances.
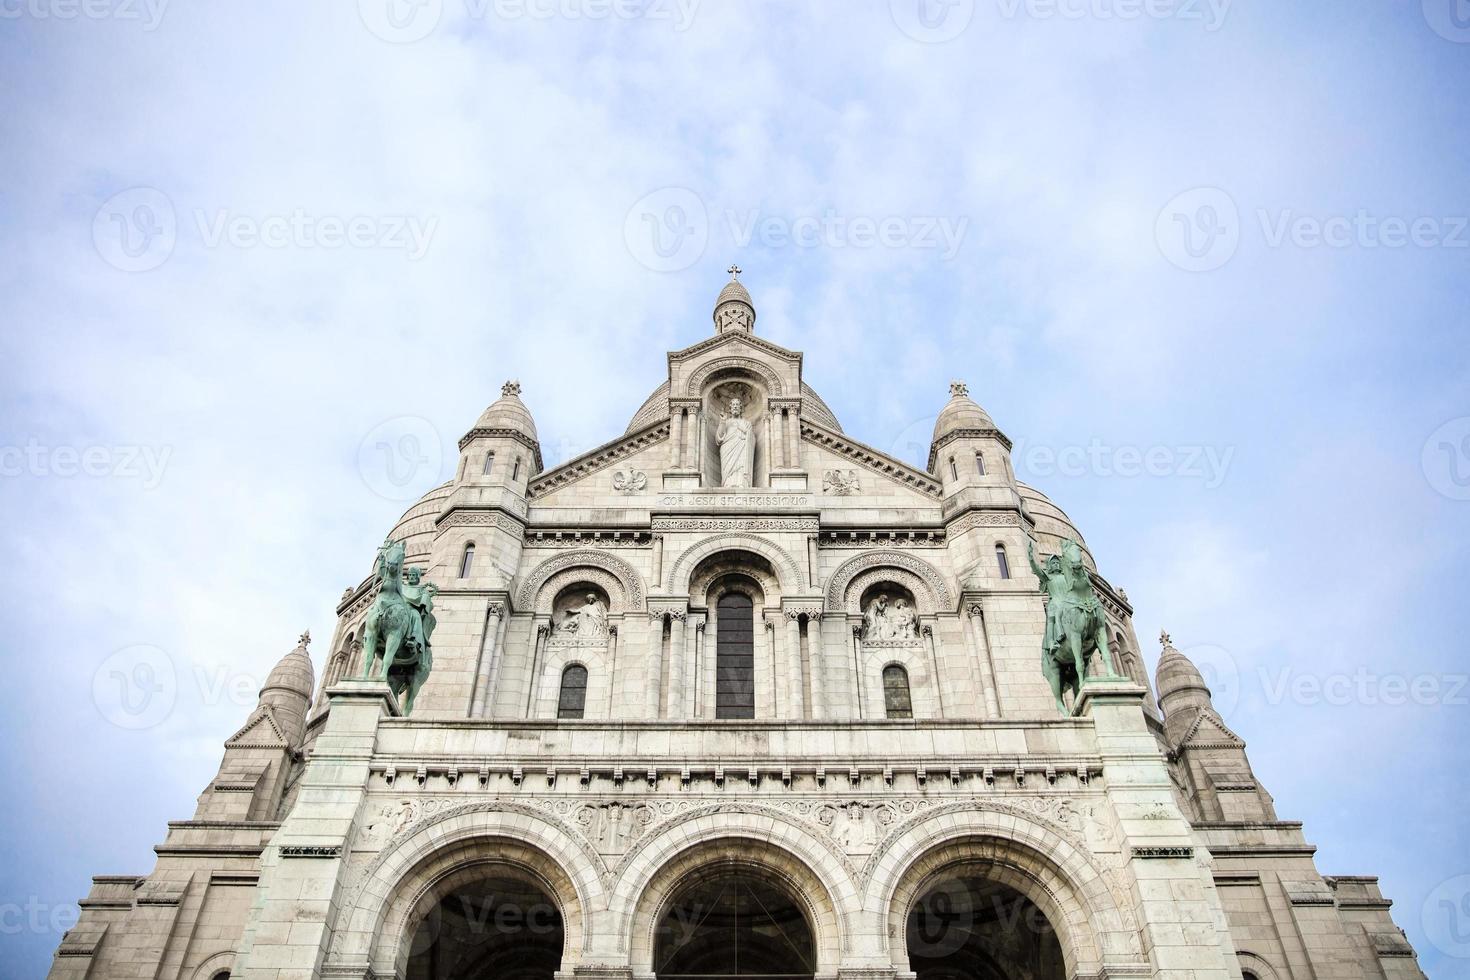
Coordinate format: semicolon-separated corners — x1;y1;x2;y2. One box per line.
653;868;817;980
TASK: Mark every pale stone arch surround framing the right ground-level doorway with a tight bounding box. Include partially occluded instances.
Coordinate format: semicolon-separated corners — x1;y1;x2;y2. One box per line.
864;807;1145;977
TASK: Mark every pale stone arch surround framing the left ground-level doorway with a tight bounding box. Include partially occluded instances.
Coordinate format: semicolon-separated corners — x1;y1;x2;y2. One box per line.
332;802;604;976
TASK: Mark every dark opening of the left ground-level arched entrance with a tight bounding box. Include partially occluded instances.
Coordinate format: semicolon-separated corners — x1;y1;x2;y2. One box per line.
406;873;564;980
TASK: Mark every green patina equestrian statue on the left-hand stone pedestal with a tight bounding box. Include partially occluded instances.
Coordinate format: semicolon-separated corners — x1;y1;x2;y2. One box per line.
362;538;438;714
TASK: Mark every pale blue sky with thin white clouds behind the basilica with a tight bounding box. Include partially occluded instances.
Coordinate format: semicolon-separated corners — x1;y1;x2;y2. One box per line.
0;0;1470;976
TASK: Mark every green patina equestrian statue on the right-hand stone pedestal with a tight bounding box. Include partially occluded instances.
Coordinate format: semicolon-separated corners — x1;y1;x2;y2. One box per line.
1026;538;1117;713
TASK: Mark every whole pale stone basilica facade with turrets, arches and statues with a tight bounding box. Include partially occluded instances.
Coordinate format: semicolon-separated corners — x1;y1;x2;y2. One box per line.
51;270;1421;980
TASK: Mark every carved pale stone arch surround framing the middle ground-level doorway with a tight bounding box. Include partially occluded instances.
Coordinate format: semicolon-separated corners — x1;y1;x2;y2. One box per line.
609;804;861;976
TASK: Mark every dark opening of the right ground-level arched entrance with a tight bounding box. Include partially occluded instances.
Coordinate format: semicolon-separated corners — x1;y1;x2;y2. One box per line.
906;870;1067;980
